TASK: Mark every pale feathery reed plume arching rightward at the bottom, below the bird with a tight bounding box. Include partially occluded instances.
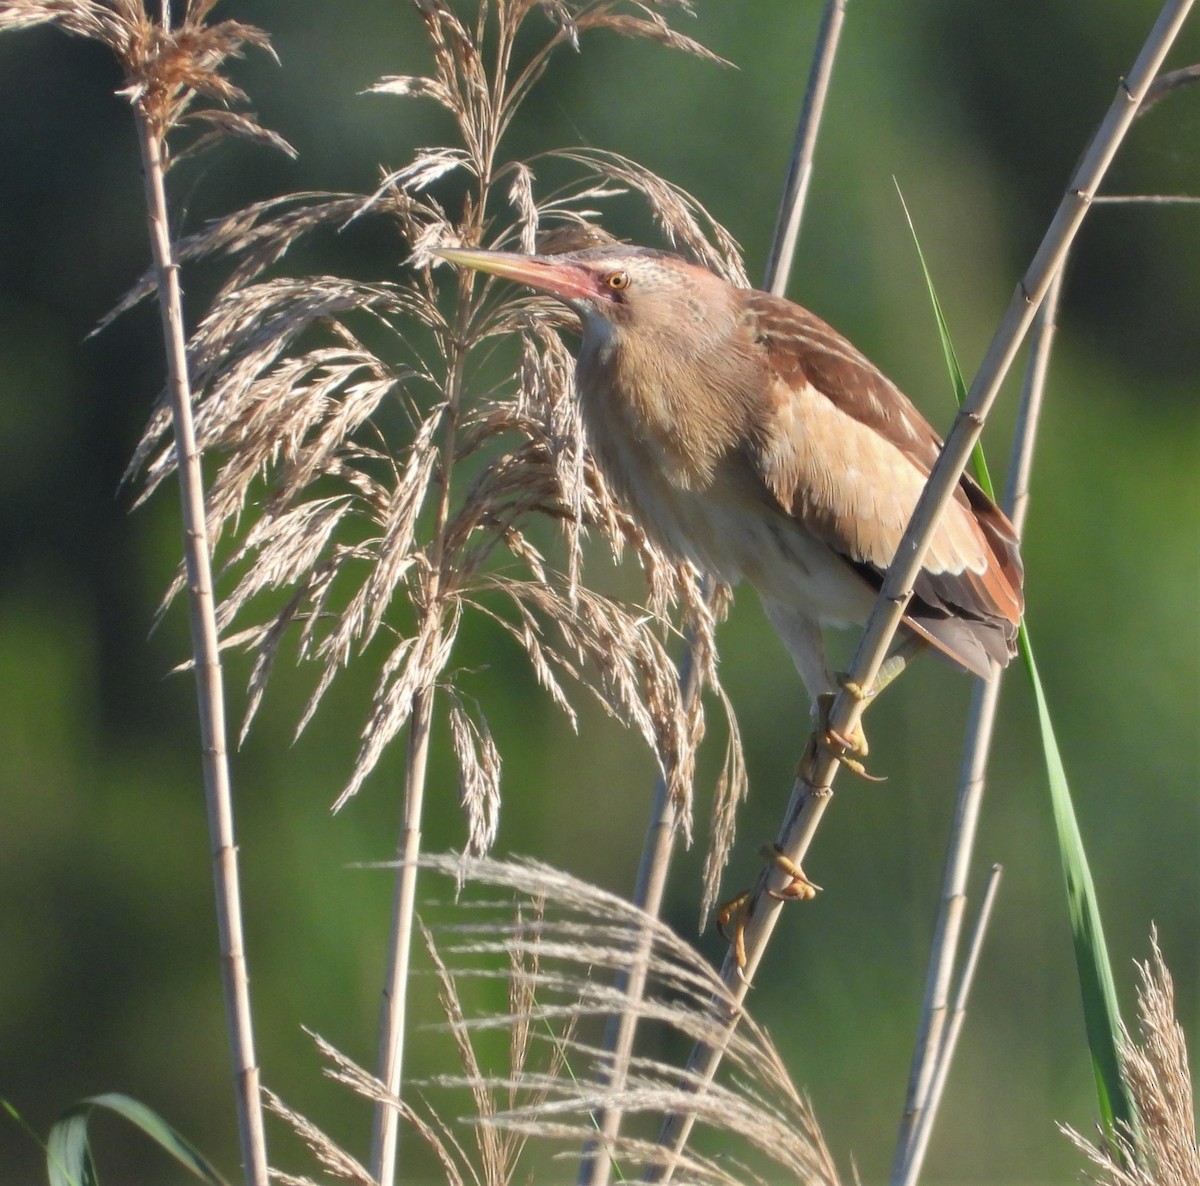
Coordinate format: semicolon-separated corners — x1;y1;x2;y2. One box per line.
268;857;840;1186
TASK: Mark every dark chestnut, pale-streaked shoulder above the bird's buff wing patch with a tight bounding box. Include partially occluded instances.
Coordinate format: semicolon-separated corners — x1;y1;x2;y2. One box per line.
742;290;942;473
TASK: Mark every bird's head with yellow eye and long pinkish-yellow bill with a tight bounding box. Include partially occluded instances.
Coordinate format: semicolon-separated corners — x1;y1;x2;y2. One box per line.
433;244;738;354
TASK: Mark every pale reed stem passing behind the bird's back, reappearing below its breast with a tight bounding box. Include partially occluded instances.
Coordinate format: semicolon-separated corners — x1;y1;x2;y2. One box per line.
578;9;846;1186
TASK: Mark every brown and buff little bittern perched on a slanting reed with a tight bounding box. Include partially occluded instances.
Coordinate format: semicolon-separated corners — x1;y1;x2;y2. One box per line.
436;244;1022;720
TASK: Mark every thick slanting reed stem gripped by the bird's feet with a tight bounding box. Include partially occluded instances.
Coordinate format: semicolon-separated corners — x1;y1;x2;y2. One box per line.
650;0;1193;1181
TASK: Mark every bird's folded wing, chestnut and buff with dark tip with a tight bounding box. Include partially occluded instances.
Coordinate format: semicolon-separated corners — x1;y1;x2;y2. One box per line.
744;292;1022;676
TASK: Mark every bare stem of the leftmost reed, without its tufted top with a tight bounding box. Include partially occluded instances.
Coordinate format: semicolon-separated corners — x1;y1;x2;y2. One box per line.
134;115;268;1186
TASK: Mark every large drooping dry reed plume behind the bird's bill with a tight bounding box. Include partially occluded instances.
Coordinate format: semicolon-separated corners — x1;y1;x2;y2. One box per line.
121;2;744;852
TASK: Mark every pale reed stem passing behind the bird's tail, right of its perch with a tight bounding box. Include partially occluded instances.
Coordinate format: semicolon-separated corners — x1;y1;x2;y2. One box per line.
892;269;1063;1186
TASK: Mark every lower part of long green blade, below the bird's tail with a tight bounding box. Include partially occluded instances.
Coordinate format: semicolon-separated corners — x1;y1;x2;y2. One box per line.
1020;625;1138;1140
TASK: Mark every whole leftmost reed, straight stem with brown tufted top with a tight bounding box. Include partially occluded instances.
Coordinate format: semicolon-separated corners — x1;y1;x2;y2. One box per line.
0;0;293;1186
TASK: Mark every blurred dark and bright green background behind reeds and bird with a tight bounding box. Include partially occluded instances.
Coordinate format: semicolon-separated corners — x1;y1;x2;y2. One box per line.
0;0;1200;1184
